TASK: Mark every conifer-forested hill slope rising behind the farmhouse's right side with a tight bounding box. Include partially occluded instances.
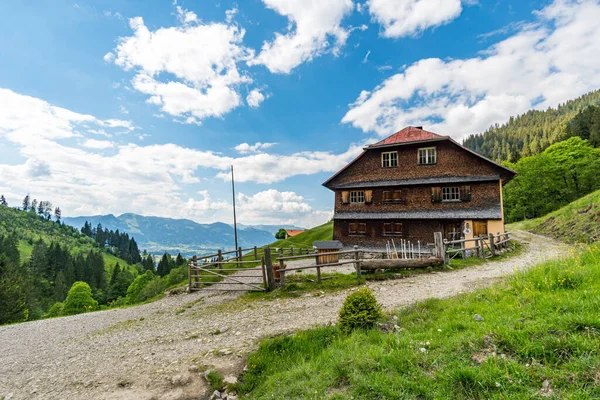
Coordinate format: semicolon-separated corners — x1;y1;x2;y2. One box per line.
463;90;600;162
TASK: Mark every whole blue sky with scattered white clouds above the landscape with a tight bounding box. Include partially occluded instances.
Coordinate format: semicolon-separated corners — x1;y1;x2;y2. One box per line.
0;0;600;226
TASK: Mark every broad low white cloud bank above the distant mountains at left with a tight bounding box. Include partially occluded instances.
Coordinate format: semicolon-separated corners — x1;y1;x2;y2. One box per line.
0;89;360;224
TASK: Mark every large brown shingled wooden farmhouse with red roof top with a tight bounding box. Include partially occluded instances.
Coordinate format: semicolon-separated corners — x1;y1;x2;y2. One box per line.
323;126;516;246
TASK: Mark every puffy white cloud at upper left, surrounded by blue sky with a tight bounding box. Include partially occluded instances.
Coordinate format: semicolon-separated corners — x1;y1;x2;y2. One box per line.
105;6;254;123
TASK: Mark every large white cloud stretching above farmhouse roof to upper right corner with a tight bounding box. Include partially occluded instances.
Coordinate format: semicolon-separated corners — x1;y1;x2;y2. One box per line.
342;0;600;138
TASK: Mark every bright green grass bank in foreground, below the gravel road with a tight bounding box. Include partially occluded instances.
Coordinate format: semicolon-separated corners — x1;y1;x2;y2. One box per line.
238;245;600;399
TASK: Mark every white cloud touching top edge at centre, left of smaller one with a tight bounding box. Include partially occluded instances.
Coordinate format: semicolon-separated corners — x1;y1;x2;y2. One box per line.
248;0;354;74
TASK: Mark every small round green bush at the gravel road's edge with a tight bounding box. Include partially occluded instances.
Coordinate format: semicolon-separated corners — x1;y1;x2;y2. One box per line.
339;287;383;333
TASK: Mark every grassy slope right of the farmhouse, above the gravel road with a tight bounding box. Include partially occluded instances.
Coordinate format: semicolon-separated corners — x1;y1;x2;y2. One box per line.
508;190;600;243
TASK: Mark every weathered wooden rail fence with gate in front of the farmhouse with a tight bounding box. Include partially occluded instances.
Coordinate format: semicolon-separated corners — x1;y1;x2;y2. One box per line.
188;232;511;291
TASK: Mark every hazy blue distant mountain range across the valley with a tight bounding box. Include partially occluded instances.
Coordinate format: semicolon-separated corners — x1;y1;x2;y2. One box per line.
63;213;302;256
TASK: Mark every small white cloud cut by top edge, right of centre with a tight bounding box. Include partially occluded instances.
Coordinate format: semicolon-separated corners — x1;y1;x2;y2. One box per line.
367;0;462;38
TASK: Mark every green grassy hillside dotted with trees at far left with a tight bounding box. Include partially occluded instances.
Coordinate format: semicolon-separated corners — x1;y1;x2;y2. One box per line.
0;207;130;273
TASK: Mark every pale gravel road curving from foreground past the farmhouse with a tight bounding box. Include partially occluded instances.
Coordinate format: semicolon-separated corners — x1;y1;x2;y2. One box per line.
0;232;568;400
